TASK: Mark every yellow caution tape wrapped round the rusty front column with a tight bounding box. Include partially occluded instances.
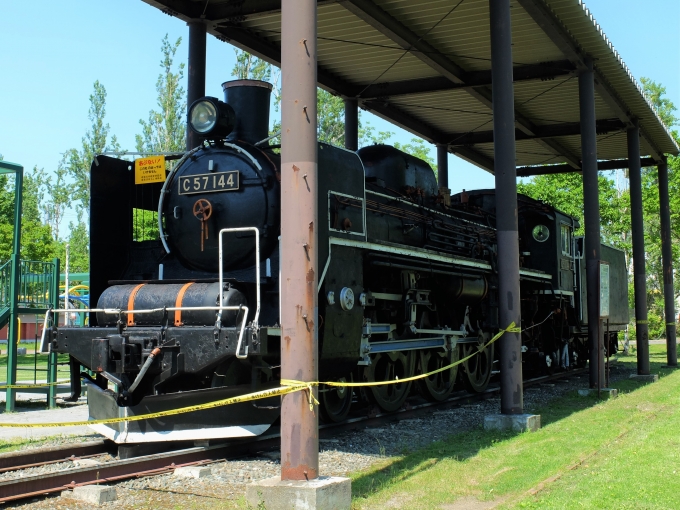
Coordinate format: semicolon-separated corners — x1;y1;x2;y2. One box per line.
0;322;521;428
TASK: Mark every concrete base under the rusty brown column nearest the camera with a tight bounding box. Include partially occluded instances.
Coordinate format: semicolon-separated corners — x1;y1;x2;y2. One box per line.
246;476;352;510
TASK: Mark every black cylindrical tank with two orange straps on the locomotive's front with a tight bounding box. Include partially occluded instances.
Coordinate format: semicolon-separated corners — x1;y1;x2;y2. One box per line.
97;282;246;327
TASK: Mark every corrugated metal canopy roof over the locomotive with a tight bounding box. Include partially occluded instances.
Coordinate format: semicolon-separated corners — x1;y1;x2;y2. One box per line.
143;0;678;175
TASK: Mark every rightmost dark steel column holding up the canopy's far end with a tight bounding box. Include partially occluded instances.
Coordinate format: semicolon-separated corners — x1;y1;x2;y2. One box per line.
657;158;678;367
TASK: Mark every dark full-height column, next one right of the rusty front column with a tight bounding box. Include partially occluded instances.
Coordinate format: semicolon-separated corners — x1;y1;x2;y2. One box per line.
489;0;524;414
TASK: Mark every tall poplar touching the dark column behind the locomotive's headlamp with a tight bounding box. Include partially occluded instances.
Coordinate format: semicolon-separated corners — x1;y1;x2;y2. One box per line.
135;34;186;153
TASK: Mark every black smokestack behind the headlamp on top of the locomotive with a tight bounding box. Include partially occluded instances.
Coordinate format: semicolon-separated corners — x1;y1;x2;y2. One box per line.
222;80;272;143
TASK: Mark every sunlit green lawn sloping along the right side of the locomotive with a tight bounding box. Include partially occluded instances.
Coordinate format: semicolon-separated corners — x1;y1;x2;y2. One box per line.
352;346;680;509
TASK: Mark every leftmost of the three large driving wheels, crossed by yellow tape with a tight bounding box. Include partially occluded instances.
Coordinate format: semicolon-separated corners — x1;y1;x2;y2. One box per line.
364;351;416;412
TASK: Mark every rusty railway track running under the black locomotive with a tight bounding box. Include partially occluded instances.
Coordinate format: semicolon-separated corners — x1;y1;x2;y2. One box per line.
0;369;587;503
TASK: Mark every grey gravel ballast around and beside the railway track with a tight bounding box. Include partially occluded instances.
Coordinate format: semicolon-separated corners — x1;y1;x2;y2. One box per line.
0;364;634;510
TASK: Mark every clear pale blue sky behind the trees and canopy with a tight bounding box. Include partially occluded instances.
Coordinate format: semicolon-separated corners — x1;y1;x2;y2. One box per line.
0;0;680;227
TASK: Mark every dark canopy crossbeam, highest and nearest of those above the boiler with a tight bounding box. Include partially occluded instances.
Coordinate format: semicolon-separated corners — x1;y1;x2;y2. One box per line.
354;60;574;99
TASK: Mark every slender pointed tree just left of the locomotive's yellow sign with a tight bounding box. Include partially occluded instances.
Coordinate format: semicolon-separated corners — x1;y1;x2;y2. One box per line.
62;80;120;217
